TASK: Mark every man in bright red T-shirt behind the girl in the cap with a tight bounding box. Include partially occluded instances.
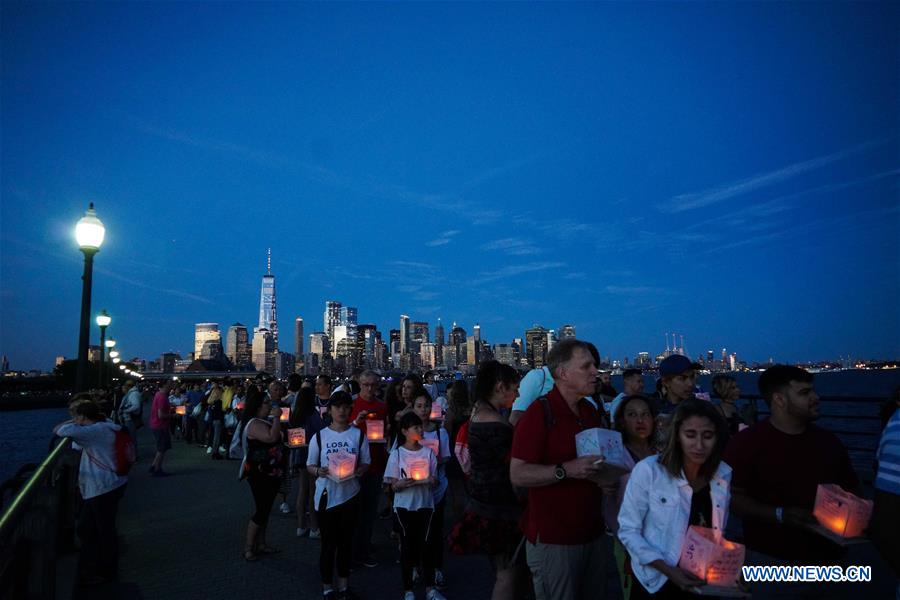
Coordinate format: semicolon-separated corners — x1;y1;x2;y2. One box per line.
350;370;387;567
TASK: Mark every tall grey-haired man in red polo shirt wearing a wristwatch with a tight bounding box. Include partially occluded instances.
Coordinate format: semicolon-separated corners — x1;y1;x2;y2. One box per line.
509;340;614;600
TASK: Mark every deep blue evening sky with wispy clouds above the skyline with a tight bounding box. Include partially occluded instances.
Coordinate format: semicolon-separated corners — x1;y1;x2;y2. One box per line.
0;2;900;369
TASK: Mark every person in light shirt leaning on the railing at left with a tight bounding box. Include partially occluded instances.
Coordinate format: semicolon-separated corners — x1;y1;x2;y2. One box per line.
53;399;128;585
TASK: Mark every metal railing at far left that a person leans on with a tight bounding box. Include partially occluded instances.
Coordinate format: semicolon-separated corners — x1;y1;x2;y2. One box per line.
0;438;80;600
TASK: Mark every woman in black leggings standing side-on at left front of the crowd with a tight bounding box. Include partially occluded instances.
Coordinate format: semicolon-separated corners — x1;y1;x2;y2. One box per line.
240;386;283;562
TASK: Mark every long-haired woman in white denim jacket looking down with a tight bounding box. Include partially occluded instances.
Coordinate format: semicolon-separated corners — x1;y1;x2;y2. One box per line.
619;399;731;600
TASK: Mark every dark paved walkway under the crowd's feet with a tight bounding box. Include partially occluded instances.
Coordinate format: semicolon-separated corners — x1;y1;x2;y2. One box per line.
68;428;896;600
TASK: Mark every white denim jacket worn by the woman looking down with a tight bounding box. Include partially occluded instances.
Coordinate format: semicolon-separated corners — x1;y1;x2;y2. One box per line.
619;455;731;594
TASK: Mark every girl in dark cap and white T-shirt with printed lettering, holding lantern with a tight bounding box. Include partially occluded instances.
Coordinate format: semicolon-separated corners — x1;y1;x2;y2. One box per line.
306;392;372;598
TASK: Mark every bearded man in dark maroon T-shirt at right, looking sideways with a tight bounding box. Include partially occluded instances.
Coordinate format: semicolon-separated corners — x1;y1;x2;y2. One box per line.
724;365;859;568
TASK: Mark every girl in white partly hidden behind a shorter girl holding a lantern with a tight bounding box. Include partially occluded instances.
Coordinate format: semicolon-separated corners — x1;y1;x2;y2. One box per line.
413;394;450;588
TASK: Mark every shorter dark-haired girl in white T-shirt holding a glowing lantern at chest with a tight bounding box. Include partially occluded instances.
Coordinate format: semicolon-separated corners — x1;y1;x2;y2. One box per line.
384;412;445;600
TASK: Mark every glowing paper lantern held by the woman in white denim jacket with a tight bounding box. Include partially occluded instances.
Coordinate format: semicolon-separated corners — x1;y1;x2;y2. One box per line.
678;525;745;587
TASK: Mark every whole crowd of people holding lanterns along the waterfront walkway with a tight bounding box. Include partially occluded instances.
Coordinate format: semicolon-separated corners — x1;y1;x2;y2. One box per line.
51;340;900;600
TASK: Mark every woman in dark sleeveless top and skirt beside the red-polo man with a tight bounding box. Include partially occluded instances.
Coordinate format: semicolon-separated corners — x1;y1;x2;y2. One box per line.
450;360;527;600
